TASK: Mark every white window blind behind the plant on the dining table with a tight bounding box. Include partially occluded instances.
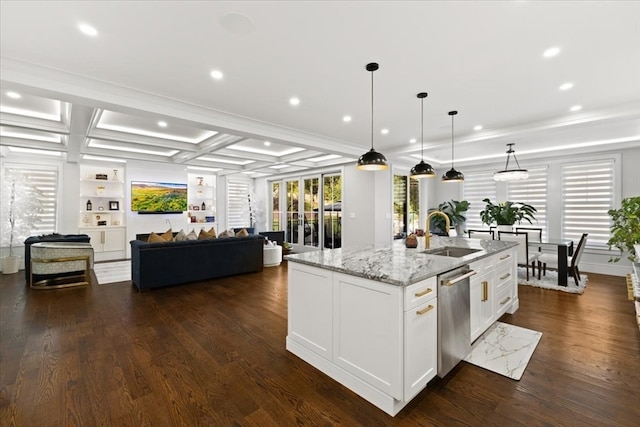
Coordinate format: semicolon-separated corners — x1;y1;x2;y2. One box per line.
507;166;548;239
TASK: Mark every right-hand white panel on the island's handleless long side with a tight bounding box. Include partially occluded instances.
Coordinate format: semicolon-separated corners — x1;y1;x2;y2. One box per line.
333;273;403;400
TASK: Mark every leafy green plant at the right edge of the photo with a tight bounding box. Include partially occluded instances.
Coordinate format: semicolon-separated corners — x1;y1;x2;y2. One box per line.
607;196;640;262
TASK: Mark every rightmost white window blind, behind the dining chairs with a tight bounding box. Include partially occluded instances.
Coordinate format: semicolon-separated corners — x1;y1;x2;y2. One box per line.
562;159;615;247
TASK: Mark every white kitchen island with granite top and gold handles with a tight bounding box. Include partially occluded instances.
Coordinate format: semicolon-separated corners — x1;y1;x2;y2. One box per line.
286;237;518;415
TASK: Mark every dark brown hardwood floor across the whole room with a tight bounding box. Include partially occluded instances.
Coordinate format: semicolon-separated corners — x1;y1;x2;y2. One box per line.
0;263;640;426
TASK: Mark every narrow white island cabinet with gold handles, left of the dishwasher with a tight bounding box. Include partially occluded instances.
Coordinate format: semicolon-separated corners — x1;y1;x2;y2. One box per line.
403;277;438;402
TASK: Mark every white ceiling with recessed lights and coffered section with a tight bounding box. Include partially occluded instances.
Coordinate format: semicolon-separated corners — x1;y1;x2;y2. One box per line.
0;0;640;176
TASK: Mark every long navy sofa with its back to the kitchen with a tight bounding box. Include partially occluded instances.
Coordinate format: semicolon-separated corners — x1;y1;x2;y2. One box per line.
130;235;264;291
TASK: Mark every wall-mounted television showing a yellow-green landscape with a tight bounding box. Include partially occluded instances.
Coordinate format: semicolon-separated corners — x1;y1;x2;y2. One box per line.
131;181;187;214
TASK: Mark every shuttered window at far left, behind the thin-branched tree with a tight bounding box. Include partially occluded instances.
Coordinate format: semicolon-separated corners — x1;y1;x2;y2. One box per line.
1;164;58;246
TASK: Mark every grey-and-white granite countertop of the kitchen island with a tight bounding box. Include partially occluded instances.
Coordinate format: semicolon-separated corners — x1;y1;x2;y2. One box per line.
284;236;517;286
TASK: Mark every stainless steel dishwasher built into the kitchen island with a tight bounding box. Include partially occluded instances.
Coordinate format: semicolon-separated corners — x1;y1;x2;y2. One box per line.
438;265;476;378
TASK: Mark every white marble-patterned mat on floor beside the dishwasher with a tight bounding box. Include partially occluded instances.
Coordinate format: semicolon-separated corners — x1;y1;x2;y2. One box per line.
464;322;542;380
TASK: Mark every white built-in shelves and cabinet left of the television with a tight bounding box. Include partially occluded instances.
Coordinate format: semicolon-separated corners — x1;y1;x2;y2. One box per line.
78;165;126;261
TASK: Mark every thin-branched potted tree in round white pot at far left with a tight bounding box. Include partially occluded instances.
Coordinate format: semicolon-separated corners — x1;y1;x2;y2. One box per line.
2;169;40;274
